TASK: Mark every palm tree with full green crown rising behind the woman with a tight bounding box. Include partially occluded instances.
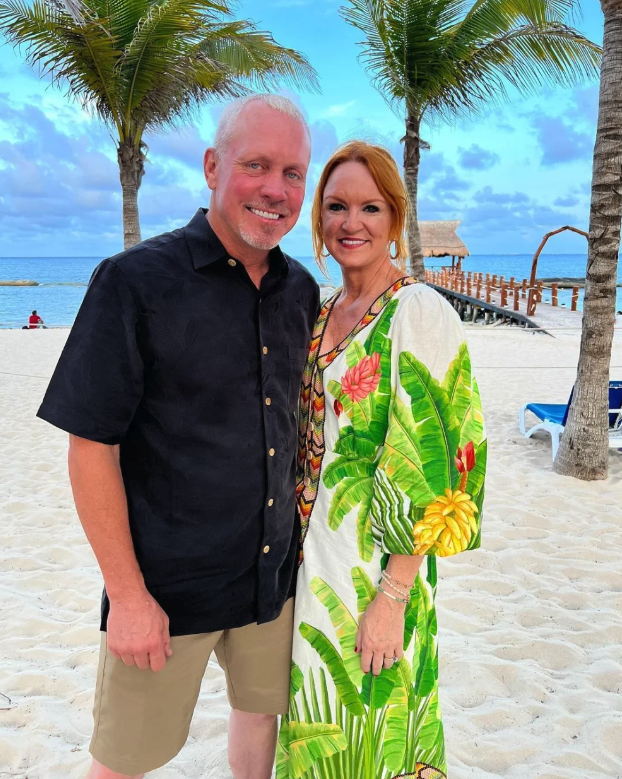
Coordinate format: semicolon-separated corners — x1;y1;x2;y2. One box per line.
341;0;600;279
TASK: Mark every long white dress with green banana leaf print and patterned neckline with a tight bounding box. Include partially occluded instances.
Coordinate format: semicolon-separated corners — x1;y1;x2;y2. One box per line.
277;277;486;779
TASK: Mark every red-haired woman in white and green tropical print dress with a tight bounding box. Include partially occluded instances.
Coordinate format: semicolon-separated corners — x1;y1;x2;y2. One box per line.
277;142;486;779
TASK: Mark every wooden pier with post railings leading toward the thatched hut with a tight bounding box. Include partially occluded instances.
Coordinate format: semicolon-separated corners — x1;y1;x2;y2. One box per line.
426;267;582;330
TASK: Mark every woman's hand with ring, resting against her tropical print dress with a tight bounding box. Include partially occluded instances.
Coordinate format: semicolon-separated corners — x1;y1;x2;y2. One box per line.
355;592;406;676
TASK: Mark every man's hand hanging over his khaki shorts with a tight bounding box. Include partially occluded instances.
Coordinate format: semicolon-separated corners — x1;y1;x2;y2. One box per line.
107;590;173;671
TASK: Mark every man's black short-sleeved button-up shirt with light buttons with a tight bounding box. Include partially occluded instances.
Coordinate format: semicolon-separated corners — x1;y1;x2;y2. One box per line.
38;210;319;635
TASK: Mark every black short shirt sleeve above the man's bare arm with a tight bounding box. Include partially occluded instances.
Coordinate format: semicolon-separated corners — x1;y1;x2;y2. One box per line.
37;260;143;445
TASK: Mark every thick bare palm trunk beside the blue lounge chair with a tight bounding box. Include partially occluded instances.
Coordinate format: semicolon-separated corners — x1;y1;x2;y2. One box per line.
553;0;622;481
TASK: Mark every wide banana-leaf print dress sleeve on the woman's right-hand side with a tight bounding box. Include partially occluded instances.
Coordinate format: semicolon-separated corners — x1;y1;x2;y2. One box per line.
370;284;486;557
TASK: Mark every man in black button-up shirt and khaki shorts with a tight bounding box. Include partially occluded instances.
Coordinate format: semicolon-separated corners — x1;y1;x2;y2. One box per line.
39;95;319;779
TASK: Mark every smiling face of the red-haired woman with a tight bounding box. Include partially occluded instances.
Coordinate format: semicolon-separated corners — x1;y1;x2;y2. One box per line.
322;162;393;270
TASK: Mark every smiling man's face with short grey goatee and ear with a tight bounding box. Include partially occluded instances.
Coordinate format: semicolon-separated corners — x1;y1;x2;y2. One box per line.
205;103;311;251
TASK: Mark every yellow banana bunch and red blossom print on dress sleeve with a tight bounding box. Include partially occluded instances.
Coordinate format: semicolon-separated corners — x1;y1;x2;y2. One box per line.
413;441;478;557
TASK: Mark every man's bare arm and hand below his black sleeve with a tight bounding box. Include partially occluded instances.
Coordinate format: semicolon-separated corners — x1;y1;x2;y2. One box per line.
69;435;172;671
